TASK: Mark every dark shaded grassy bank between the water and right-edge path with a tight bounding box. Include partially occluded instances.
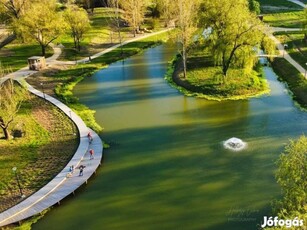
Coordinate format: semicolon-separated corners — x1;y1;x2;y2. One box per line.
272;58;307;108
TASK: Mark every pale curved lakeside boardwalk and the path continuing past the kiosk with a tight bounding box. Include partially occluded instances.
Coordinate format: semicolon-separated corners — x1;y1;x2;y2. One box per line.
0;29;170;227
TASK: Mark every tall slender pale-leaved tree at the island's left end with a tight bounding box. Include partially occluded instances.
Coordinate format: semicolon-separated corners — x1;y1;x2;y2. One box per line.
176;0;199;78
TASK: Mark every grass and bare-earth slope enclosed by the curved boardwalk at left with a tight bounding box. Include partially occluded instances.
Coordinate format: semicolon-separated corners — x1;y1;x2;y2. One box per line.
0;92;78;212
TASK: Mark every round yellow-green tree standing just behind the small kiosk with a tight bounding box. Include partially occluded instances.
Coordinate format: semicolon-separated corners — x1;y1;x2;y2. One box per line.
15;0;65;56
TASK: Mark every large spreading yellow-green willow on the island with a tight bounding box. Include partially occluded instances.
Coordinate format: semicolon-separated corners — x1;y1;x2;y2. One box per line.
202;0;264;82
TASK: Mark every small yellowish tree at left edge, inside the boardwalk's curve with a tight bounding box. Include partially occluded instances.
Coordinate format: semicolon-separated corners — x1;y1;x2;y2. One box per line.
0;79;28;140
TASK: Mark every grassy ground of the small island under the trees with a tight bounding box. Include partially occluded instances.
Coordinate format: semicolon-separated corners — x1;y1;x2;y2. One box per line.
166;51;269;100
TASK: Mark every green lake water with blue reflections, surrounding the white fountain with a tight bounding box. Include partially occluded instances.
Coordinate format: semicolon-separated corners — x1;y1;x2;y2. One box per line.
33;45;307;230
